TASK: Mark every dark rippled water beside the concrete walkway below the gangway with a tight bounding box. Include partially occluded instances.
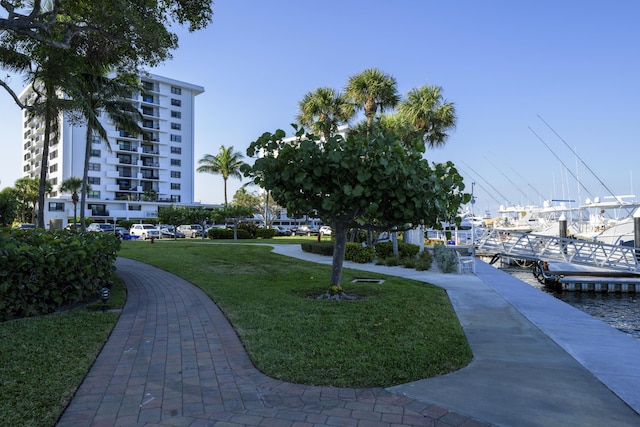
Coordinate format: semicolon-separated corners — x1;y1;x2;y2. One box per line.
502;268;640;339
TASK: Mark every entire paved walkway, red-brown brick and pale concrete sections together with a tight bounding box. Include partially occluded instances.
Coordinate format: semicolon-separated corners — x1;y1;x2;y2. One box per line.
58;245;640;427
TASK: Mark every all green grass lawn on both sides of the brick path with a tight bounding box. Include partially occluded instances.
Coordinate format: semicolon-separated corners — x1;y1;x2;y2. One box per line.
0;241;472;427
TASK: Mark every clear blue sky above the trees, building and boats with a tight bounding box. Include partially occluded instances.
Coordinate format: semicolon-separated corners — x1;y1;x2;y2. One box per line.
0;0;640;217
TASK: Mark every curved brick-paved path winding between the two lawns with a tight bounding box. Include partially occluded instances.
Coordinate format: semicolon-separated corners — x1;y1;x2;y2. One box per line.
58;258;490;427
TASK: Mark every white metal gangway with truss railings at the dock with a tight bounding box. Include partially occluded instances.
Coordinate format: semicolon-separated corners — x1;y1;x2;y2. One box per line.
475;229;640;274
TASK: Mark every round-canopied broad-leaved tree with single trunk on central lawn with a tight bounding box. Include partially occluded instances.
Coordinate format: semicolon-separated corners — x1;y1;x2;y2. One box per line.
244;125;470;289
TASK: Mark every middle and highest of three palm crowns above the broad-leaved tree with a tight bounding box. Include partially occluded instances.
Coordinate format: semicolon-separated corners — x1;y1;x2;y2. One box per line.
345;68;400;126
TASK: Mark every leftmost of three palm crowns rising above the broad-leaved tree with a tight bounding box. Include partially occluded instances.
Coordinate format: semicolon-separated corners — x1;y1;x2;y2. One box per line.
297;87;355;141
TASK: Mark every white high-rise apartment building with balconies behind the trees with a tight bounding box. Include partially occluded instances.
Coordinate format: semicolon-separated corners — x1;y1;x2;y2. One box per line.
20;74;204;228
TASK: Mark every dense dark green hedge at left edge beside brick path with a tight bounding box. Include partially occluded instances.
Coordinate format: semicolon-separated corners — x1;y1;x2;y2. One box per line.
0;230;120;321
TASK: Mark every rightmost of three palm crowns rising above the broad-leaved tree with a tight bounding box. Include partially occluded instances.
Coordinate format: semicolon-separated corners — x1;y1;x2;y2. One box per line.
398;85;456;148
